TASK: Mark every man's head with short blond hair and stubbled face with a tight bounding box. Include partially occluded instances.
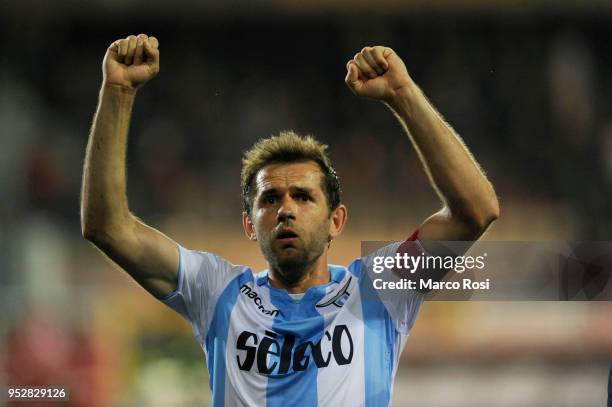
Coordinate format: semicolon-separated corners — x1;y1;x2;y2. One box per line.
241;131;347;283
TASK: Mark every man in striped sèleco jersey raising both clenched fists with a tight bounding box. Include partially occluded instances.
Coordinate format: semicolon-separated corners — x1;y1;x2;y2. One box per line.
81;34;499;406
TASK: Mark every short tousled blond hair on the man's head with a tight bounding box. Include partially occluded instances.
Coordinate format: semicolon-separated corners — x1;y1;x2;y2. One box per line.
240;130;341;214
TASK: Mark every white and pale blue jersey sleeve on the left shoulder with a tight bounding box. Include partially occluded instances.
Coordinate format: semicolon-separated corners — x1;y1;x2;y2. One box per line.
162;245;241;342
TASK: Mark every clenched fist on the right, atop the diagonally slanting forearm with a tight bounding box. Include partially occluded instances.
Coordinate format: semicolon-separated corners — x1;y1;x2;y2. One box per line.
345;46;412;102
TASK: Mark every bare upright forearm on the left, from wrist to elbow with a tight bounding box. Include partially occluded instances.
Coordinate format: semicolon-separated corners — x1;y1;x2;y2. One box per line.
81;85;136;238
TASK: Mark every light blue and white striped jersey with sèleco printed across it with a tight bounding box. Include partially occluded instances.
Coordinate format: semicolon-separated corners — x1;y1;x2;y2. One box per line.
163;241;424;407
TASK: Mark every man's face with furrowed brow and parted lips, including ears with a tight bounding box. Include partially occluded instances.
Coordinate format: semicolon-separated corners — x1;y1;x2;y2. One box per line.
244;161;345;283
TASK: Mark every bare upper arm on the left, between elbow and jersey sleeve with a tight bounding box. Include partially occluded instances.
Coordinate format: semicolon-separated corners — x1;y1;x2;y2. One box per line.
90;215;179;298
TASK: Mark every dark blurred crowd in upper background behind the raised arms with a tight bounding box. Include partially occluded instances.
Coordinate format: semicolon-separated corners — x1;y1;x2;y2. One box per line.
0;16;612;240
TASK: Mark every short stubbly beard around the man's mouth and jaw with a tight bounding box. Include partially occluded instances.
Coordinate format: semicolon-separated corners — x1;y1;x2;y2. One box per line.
259;222;329;285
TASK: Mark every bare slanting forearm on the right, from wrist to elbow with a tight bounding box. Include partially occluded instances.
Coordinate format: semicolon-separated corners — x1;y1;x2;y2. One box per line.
388;84;499;228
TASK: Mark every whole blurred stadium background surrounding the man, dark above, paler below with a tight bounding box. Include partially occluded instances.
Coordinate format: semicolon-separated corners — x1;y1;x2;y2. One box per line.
0;0;612;406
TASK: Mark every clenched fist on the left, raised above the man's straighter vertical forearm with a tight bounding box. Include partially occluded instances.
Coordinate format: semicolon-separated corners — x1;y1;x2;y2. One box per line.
102;34;159;89
